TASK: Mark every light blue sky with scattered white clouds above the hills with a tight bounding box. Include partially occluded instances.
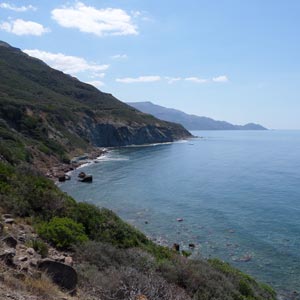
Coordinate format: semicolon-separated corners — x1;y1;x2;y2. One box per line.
0;0;300;129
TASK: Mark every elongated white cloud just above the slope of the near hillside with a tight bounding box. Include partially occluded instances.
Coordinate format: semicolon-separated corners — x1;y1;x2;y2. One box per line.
23;49;109;78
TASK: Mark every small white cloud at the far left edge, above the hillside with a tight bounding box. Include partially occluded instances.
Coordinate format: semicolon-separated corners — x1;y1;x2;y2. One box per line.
0;19;50;36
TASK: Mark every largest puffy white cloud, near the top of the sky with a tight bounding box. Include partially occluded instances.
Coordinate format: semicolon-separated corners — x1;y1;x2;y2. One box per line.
51;2;138;36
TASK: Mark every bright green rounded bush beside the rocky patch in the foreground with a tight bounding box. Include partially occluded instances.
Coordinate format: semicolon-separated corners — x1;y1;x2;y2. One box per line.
38;217;88;249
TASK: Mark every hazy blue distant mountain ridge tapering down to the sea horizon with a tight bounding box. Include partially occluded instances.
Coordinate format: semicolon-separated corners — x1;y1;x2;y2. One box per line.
127;102;267;130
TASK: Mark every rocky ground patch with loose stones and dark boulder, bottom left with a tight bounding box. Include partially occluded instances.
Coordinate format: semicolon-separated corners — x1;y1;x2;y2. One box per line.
0;215;78;294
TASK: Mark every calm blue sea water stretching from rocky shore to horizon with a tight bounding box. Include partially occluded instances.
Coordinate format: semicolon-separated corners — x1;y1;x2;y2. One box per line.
61;131;300;291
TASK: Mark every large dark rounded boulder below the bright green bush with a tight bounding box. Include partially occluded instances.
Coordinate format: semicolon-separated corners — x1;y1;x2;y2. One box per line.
38;259;78;291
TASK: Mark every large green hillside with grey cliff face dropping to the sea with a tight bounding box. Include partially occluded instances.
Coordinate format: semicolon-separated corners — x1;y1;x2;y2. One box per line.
0;42;191;169
